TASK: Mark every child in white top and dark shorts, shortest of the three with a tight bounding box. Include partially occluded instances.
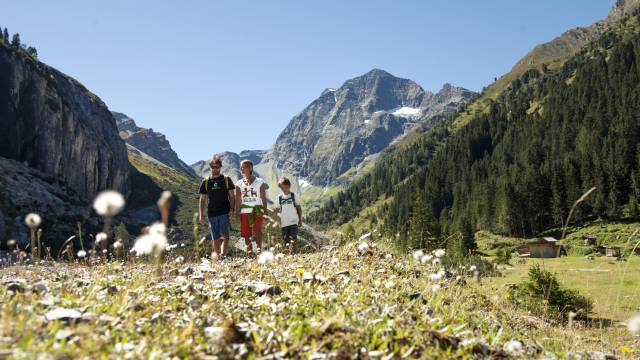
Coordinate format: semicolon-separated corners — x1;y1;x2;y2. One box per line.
276;177;302;253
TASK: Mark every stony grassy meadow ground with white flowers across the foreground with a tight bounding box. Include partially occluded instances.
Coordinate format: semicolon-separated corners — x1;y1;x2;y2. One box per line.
0;243;640;359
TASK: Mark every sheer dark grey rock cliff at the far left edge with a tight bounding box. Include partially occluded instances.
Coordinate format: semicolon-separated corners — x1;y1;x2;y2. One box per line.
0;44;129;201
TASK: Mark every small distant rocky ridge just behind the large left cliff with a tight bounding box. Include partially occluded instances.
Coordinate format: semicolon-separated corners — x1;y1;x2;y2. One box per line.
113;112;197;177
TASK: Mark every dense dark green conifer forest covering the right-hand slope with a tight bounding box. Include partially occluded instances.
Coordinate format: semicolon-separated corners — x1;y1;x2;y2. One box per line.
311;15;640;247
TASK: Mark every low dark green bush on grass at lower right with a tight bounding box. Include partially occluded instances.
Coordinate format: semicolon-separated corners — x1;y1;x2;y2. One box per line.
514;264;593;319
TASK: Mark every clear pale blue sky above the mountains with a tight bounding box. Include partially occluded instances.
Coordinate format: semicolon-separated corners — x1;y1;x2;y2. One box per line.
5;0;614;163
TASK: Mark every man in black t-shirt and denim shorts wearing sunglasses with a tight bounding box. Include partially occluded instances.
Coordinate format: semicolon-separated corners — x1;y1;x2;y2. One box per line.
198;155;235;257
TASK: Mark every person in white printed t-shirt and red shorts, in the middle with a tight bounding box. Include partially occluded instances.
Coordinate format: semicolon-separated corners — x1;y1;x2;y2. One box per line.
236;160;267;256
